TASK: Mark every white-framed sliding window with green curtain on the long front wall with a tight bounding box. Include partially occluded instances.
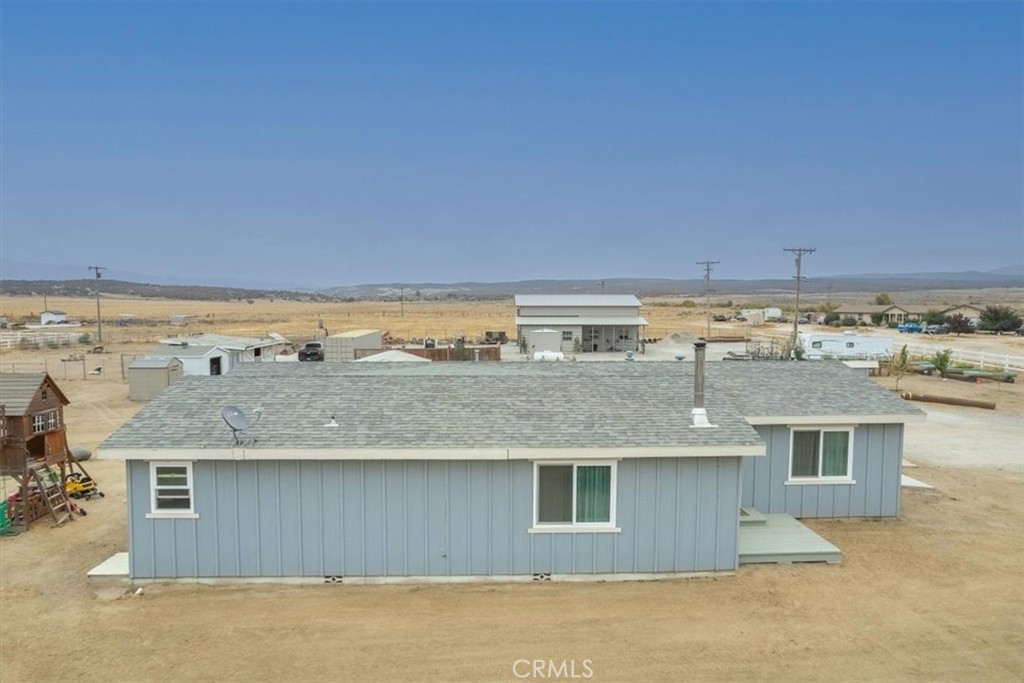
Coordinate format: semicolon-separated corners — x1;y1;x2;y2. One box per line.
531;462;618;531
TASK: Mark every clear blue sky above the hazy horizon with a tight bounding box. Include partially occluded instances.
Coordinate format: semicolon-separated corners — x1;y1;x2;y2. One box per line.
0;2;1024;286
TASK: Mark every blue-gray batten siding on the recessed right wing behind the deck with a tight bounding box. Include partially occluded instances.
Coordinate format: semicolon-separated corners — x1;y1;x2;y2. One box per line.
742;424;903;518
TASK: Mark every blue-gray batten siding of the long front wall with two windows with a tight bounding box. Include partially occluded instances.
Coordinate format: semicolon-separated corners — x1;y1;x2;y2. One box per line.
127;457;740;579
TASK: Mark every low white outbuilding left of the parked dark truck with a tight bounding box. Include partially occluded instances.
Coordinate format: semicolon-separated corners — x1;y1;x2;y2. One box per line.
148;335;290;375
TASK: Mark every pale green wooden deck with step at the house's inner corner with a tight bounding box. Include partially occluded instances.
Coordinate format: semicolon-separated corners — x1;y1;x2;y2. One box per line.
739;508;842;564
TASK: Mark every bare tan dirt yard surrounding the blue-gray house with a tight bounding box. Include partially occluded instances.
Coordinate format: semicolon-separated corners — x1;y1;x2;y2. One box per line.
0;296;1024;683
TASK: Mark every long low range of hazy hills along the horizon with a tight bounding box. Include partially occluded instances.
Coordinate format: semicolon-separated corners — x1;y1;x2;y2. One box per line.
0;254;1024;301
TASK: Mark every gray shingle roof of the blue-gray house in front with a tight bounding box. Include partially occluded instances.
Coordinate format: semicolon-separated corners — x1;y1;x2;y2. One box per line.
101;361;920;450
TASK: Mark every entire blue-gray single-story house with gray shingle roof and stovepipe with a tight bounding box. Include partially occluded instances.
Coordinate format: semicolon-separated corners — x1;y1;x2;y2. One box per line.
98;348;923;581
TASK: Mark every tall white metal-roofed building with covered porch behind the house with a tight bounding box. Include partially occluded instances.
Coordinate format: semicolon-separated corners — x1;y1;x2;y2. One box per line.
515;294;647;353
